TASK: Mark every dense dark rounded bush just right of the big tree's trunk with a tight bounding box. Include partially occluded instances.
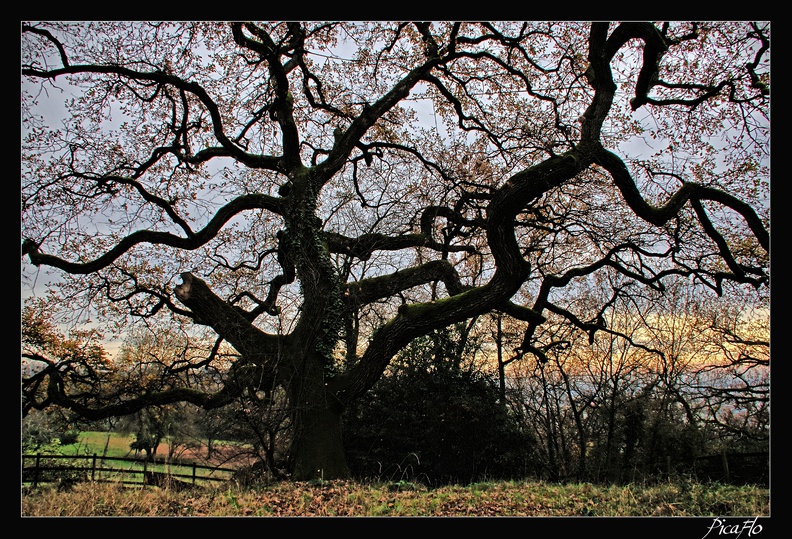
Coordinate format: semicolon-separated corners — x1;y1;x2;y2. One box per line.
344;332;533;485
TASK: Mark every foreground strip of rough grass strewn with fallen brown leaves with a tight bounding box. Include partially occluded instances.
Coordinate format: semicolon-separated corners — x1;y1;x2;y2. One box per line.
22;476;770;517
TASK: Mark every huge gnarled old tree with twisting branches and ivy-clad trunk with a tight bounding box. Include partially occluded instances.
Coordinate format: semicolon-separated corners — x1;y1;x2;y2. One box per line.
21;21;770;479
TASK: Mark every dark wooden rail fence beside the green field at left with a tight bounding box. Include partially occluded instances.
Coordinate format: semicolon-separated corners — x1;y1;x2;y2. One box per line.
22;454;235;488
